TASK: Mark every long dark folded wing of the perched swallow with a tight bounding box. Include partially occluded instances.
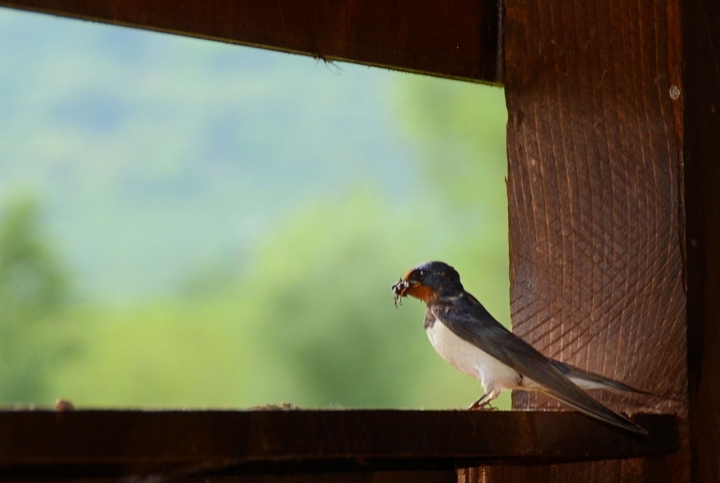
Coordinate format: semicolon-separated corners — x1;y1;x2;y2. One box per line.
428;294;647;435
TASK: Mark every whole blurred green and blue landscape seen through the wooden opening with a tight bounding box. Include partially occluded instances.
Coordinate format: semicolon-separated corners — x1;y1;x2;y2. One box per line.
0;9;509;408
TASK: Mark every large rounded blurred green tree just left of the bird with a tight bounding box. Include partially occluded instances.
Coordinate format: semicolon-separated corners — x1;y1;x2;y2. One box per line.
238;191;432;407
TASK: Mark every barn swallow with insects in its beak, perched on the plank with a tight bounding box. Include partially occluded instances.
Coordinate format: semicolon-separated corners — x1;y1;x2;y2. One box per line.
392;262;651;435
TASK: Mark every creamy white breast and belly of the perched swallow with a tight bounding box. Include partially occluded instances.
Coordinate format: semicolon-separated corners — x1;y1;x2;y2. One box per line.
425;320;521;391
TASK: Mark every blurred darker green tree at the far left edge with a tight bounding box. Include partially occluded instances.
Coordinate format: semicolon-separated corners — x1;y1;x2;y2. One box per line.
0;198;68;403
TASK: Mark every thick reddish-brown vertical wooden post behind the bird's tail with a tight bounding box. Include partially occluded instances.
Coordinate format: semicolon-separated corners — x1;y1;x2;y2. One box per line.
460;0;688;482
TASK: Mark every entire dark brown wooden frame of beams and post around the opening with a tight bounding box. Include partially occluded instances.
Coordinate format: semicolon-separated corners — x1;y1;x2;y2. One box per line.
0;0;720;482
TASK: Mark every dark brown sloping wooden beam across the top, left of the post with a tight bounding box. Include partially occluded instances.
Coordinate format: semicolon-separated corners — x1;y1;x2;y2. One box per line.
0;0;502;84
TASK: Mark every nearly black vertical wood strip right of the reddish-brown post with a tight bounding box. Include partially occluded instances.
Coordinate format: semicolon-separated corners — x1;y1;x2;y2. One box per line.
683;0;720;483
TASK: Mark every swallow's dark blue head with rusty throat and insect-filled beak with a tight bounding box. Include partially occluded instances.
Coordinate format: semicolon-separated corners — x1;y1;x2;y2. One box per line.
392;262;463;305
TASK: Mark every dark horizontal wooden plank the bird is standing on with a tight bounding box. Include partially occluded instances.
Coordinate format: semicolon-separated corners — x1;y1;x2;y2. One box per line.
0;410;677;477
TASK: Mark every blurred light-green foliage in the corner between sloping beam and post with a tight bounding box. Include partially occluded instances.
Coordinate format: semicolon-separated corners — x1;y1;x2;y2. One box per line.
398;76;507;211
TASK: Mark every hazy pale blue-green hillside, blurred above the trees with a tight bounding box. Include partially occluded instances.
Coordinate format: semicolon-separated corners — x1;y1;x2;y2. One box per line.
0;9;415;301
